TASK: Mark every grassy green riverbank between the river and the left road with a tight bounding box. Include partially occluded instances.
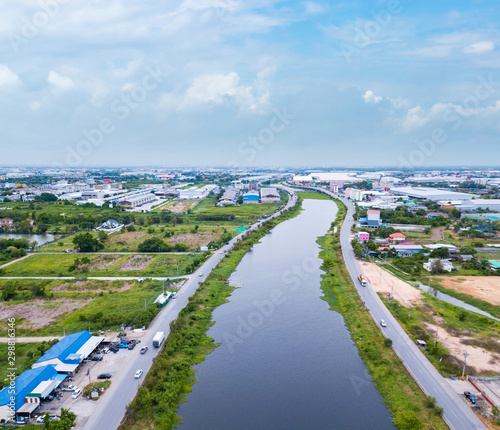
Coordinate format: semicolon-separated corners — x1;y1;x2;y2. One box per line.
120;197;301;430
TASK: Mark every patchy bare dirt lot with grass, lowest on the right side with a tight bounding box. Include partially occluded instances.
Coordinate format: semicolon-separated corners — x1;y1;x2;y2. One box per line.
424;322;500;373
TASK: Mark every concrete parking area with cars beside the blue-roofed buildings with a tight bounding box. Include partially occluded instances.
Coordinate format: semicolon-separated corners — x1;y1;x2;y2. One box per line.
33;331;147;426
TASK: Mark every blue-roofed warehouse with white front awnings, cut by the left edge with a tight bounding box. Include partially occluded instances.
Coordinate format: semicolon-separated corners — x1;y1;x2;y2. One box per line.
0;365;60;421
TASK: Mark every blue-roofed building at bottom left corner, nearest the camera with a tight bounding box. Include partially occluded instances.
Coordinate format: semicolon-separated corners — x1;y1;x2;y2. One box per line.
0;365;60;420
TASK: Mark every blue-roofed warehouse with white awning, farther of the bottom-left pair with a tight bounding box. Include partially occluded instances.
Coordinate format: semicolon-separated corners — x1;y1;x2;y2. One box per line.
32;330;104;374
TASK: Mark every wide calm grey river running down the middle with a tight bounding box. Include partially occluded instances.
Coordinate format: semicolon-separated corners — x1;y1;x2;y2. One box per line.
178;200;394;430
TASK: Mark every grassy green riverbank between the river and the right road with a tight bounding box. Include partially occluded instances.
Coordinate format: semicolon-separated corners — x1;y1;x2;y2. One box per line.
318;201;448;429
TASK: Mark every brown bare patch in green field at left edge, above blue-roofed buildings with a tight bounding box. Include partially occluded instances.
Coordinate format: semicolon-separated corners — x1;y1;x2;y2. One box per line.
0;298;93;329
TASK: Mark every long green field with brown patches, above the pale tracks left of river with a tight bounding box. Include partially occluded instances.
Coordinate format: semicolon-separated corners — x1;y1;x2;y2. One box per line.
2;254;207;277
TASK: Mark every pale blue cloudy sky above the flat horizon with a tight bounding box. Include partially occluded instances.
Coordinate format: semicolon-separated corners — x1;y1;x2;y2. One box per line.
0;0;500;169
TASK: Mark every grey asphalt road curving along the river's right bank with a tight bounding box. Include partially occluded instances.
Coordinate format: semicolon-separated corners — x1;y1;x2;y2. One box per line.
296;186;486;430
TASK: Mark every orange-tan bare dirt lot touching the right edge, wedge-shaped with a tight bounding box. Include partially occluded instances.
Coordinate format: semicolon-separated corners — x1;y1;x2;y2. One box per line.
432;276;500;306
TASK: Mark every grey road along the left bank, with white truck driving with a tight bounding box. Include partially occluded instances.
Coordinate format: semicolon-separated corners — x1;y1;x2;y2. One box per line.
82;191;297;430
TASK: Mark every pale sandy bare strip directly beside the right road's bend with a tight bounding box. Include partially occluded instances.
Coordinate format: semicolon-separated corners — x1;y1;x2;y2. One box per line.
361;263;422;307
